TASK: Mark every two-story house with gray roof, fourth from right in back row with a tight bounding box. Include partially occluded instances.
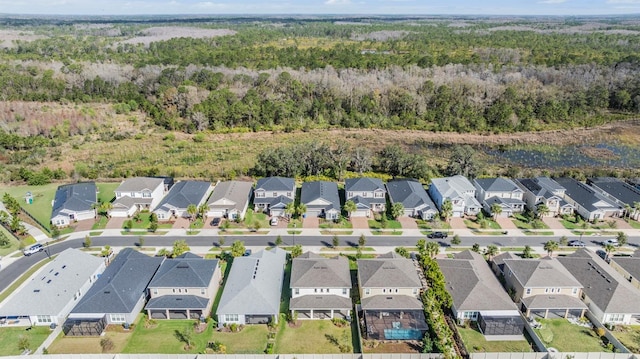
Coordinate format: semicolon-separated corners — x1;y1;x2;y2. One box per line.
473;177;525;218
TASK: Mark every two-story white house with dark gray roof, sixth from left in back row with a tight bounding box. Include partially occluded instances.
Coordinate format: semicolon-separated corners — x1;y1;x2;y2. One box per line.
300;181;341;220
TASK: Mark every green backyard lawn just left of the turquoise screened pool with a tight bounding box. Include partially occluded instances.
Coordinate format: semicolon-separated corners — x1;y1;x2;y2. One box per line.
275;320;352;354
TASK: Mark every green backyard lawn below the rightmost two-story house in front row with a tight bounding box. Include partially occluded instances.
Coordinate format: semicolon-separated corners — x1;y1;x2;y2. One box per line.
535;319;607;353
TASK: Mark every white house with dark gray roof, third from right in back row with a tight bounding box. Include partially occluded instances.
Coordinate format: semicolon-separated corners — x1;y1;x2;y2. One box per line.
516;177;575;217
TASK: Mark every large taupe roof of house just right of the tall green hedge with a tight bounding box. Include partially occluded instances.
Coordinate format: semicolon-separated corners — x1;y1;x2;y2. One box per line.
437;250;518;311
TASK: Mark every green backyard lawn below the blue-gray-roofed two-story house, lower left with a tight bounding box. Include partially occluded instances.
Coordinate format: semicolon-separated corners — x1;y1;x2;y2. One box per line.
122;320;213;354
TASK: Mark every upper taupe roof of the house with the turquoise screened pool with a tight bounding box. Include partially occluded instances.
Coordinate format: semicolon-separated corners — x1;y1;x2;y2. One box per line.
358;257;422;288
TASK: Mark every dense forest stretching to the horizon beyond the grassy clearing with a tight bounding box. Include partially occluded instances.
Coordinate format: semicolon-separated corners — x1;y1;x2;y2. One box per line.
0;17;640;181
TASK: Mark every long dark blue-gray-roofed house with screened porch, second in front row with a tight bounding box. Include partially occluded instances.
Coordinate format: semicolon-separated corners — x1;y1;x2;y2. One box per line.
63;248;164;336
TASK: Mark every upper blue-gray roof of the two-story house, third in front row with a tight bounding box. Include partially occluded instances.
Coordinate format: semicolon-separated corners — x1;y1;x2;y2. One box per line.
149;257;218;288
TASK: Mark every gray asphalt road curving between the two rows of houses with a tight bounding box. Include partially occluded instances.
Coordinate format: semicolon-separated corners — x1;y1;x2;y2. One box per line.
0;235;640;292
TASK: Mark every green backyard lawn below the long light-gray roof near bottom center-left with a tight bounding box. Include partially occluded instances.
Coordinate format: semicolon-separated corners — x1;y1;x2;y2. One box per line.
212;324;268;354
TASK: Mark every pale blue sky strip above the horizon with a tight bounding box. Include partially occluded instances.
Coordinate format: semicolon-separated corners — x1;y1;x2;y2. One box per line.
0;0;640;15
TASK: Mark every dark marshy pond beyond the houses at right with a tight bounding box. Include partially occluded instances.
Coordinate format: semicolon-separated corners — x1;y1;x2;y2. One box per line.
479;143;640;168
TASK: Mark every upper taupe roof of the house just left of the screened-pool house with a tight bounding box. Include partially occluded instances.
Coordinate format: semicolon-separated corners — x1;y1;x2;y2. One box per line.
291;252;351;288
